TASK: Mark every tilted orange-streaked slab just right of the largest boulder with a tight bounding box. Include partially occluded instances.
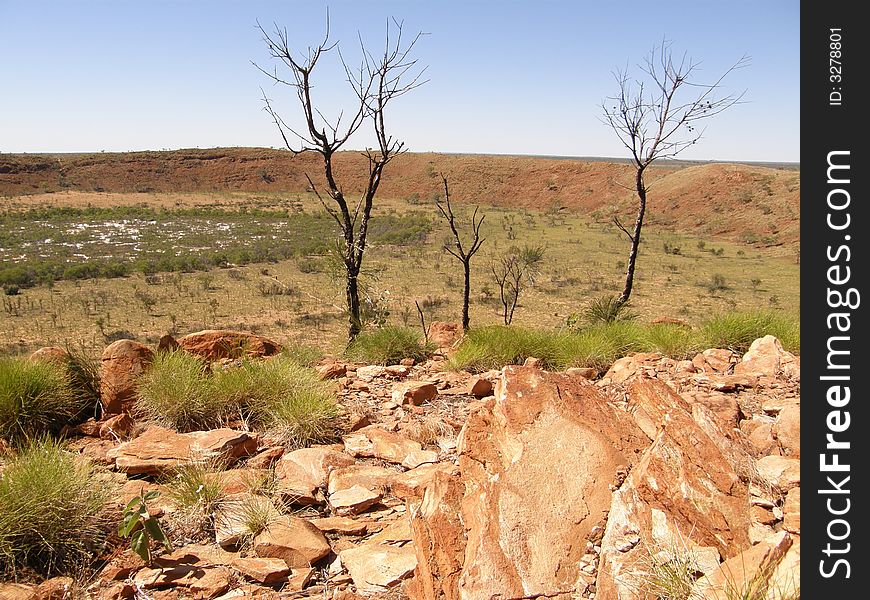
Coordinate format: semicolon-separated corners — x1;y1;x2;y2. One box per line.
596;379;750;600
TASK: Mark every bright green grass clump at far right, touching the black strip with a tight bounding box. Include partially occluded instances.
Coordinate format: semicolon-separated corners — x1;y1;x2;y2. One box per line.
700;310;801;354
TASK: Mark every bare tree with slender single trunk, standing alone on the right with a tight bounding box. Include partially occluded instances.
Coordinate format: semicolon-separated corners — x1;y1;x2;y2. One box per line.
602;41;749;306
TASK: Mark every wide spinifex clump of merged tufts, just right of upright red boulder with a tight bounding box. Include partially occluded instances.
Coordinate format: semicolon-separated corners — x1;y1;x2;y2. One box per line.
137;351;340;445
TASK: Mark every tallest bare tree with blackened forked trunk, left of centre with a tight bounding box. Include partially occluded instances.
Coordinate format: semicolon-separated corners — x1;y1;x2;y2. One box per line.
255;14;425;341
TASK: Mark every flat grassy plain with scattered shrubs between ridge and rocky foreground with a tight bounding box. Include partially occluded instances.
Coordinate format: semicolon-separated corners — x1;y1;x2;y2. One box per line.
0;192;800;354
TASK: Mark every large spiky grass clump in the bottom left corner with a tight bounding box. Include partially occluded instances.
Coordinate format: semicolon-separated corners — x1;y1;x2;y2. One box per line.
0;438;109;577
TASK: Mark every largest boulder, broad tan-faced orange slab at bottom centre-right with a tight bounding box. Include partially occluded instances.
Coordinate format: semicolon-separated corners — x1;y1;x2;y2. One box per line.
450;367;647;600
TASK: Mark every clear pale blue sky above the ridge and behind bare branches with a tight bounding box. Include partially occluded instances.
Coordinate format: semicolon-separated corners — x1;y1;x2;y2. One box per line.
0;0;800;162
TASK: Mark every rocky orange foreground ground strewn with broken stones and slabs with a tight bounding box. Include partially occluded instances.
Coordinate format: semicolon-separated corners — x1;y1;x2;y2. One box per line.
0;332;800;600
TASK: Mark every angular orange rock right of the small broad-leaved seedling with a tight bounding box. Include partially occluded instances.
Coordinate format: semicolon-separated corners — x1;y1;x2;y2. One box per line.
254;516;330;568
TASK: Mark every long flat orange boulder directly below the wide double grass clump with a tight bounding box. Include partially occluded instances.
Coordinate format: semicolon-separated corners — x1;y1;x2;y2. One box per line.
107;427;257;475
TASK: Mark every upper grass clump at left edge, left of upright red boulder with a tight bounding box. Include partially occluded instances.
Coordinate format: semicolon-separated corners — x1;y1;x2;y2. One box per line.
0;358;93;445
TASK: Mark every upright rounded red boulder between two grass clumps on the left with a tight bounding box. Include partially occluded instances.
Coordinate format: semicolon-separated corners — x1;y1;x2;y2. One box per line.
100;340;154;415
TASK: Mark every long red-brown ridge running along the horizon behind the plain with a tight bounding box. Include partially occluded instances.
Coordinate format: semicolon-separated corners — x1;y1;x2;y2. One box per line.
0;148;800;252
